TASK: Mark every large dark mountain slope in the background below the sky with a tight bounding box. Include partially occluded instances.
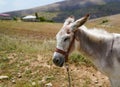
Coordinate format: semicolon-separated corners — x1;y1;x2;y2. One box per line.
4;0;120;22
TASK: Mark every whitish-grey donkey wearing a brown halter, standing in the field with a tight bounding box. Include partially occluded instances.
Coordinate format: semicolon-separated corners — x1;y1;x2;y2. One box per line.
53;15;120;87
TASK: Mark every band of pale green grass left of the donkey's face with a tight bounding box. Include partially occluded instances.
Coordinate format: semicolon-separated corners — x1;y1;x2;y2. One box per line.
0;35;55;53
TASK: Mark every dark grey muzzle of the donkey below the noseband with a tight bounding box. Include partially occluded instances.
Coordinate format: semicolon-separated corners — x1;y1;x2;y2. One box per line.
53;53;65;67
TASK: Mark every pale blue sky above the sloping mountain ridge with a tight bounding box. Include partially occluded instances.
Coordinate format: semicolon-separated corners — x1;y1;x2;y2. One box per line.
0;0;63;13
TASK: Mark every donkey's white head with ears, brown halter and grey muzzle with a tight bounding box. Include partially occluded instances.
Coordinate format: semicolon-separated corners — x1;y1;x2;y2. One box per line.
53;15;89;67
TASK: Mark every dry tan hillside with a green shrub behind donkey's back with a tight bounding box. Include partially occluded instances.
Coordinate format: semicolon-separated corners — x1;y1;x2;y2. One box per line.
88;14;120;33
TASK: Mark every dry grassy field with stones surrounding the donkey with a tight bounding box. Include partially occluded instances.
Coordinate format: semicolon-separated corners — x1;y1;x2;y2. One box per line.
0;16;120;87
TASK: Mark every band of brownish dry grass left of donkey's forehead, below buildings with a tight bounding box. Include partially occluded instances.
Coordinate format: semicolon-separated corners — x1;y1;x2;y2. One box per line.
0;21;62;39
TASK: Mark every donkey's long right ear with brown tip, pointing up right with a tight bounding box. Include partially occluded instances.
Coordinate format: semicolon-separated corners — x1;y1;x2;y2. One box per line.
71;14;89;31
